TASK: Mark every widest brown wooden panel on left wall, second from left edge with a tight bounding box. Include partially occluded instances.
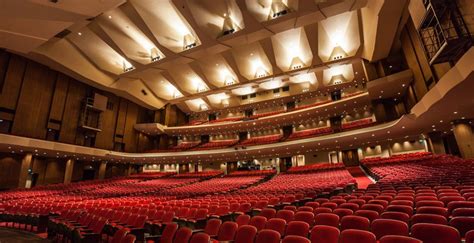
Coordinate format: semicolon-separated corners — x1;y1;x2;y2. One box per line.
12;62;56;139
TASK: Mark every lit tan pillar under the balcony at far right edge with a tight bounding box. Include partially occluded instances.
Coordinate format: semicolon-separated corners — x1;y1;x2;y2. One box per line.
453;121;474;159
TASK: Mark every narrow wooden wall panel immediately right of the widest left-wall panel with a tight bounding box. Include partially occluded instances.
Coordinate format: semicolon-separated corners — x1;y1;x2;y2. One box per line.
49;73;69;121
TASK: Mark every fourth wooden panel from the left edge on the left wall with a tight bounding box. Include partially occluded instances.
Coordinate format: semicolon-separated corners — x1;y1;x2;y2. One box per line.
59;81;86;144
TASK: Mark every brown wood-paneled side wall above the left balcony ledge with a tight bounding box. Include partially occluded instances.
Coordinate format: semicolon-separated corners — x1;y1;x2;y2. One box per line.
0;50;153;152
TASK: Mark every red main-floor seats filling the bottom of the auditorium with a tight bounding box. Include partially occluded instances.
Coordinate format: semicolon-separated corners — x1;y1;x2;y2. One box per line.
0;153;474;243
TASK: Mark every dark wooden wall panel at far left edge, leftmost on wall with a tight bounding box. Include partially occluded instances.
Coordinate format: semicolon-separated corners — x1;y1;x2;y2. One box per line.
0;55;26;110
